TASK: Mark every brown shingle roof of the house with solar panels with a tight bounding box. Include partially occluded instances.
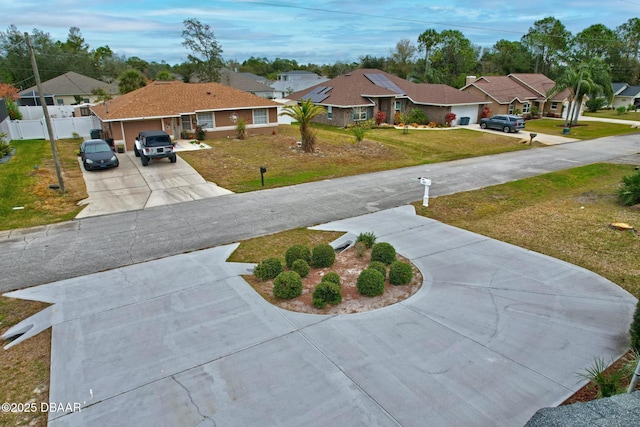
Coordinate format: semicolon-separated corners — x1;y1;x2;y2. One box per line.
287;69;486;107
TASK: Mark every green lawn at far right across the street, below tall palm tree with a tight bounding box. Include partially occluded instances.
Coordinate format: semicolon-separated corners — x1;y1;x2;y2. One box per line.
525;118;640;139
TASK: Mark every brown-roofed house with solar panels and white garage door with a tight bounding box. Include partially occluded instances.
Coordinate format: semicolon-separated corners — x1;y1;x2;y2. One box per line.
287;69;489;127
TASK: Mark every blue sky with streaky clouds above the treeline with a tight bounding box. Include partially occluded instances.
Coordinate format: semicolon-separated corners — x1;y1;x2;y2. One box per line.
0;0;640;64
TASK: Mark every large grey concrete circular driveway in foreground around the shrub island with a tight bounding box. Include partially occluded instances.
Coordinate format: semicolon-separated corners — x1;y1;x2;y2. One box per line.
7;206;635;427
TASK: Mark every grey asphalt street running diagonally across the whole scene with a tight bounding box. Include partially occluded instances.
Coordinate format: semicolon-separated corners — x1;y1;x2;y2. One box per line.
0;134;640;292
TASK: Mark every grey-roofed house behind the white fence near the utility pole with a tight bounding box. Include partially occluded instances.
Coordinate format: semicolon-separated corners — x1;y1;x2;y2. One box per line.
18;71;118;106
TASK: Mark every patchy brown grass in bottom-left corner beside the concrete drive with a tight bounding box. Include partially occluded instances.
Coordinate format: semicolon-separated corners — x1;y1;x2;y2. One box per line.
0;297;51;426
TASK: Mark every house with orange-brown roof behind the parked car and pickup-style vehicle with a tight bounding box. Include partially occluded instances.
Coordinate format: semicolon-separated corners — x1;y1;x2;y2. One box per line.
90;81;280;150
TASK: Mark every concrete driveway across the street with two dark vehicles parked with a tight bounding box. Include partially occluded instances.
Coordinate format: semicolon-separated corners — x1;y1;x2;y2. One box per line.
76;151;231;218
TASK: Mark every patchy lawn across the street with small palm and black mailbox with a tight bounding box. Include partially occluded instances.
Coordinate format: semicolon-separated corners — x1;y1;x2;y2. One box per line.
180;125;530;192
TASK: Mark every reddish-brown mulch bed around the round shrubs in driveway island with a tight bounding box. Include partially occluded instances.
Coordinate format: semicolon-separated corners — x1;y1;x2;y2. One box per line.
245;248;422;314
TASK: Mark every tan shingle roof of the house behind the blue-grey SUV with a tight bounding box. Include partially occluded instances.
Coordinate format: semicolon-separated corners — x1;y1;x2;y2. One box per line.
463;73;569;104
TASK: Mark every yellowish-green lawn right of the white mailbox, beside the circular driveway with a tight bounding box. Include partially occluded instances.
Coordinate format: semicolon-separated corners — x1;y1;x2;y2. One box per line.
414;164;640;298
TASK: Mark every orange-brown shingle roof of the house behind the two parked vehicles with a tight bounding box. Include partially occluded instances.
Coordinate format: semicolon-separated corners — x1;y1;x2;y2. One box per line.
91;81;279;121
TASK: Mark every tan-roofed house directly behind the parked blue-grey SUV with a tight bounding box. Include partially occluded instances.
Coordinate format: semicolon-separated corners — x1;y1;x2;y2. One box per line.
460;73;570;117
